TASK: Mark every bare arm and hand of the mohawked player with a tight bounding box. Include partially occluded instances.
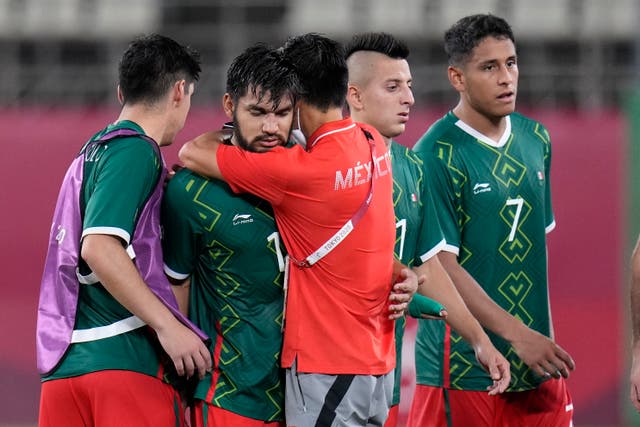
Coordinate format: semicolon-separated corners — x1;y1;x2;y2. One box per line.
414;256;511;395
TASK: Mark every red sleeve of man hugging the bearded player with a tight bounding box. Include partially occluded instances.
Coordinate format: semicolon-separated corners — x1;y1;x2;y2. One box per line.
217;145;300;205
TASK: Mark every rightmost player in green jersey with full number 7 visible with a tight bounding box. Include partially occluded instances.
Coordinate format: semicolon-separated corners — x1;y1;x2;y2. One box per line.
409;14;574;427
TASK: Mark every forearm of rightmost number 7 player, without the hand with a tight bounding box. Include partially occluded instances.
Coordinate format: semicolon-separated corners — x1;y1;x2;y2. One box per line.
438;252;526;342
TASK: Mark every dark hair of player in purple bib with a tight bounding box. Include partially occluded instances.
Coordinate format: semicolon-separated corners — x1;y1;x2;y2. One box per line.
118;34;200;104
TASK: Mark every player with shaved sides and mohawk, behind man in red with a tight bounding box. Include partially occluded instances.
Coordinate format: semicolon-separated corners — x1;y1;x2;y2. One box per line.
346;33;509;427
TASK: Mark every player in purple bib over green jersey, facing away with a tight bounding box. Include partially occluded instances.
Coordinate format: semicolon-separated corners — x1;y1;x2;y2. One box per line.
37;35;211;427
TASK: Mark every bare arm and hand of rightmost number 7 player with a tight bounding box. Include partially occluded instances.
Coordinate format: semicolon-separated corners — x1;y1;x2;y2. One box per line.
438;251;575;378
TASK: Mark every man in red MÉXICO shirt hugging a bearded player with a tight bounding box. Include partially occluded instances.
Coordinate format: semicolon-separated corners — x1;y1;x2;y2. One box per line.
180;34;417;427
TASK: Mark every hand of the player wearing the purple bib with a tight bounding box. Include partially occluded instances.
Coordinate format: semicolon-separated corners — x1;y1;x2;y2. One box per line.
156;320;212;378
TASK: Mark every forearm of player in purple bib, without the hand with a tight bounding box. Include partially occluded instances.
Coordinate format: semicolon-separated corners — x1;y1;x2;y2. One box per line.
82;234;177;331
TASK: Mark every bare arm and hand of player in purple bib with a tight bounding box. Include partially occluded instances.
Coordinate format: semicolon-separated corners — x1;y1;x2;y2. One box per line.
81;234;212;378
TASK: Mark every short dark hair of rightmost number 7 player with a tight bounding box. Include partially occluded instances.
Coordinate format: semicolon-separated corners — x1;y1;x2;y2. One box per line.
444;14;516;66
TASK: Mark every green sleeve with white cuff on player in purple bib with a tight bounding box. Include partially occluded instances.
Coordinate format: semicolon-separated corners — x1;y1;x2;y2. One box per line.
82;138;161;244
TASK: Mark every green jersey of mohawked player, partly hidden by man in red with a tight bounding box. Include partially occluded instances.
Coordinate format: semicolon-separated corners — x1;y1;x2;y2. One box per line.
390;141;443;405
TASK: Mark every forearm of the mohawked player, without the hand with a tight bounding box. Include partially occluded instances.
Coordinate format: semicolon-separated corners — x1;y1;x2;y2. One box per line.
415;257;489;348
